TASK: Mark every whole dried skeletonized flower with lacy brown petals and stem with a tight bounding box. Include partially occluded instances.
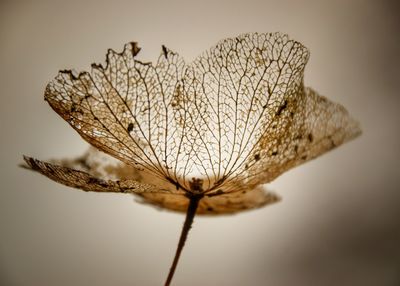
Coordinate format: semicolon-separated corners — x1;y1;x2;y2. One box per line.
24;33;361;285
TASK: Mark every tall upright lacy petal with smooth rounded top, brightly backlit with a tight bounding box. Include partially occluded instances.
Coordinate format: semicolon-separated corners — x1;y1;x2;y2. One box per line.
180;33;309;189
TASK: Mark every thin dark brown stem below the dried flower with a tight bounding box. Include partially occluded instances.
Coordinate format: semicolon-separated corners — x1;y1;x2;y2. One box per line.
165;196;202;286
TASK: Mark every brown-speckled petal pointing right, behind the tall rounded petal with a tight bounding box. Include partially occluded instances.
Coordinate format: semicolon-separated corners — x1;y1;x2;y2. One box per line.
230;88;361;186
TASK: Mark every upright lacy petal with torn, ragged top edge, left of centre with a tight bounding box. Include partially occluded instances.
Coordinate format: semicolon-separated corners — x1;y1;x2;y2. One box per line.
45;43;184;184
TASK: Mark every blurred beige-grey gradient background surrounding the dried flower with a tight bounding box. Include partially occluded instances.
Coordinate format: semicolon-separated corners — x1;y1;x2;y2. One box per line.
0;0;400;286
